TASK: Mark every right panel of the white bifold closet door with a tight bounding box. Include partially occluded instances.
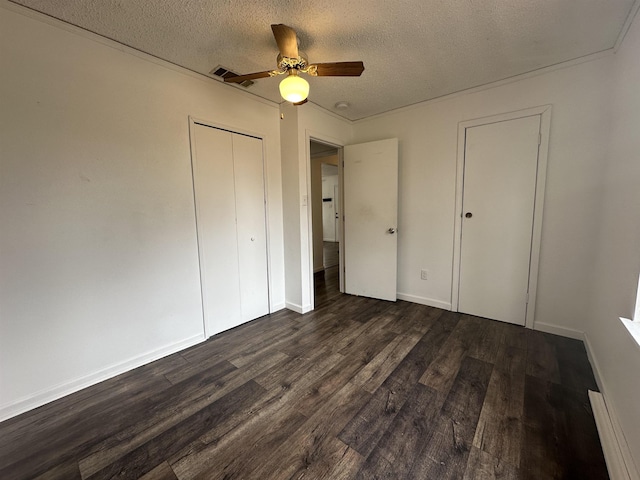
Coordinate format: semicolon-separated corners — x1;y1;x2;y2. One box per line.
233;134;269;322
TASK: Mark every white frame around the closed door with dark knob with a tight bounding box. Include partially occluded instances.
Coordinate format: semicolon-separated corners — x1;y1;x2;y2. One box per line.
451;105;551;328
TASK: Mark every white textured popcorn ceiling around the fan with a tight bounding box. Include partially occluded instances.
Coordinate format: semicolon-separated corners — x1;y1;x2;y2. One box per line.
12;0;635;120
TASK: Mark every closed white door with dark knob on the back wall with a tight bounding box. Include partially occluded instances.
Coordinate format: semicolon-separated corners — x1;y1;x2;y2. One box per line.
458;115;540;325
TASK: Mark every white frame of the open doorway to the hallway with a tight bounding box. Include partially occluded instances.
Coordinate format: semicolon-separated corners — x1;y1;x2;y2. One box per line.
305;130;344;311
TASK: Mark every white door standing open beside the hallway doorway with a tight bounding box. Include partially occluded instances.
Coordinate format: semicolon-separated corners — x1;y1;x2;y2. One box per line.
343;138;398;301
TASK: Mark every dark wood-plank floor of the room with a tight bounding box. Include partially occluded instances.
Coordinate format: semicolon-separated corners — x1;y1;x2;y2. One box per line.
0;267;608;480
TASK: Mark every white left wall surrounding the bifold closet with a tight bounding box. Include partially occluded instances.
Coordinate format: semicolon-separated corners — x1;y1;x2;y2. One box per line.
0;3;284;419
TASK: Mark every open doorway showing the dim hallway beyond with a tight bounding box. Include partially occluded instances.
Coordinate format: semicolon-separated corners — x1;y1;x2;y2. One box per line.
310;140;341;307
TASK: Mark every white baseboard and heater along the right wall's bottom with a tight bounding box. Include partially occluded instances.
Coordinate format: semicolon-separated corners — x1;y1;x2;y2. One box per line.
584;333;640;480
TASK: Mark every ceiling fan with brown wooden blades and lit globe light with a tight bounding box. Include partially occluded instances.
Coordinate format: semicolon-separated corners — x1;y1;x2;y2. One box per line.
224;24;364;105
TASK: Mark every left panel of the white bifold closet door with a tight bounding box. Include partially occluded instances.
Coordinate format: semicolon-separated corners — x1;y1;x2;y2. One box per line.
193;124;242;336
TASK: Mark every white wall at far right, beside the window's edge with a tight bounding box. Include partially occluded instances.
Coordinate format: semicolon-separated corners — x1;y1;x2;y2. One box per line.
585;9;640;471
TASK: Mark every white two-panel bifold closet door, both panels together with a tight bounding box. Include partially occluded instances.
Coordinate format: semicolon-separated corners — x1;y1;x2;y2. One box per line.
192;123;269;336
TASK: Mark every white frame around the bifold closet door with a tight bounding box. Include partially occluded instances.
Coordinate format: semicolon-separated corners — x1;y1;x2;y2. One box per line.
188;115;273;339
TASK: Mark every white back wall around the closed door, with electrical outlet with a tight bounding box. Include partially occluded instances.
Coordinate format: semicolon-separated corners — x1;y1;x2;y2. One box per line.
354;56;611;330
